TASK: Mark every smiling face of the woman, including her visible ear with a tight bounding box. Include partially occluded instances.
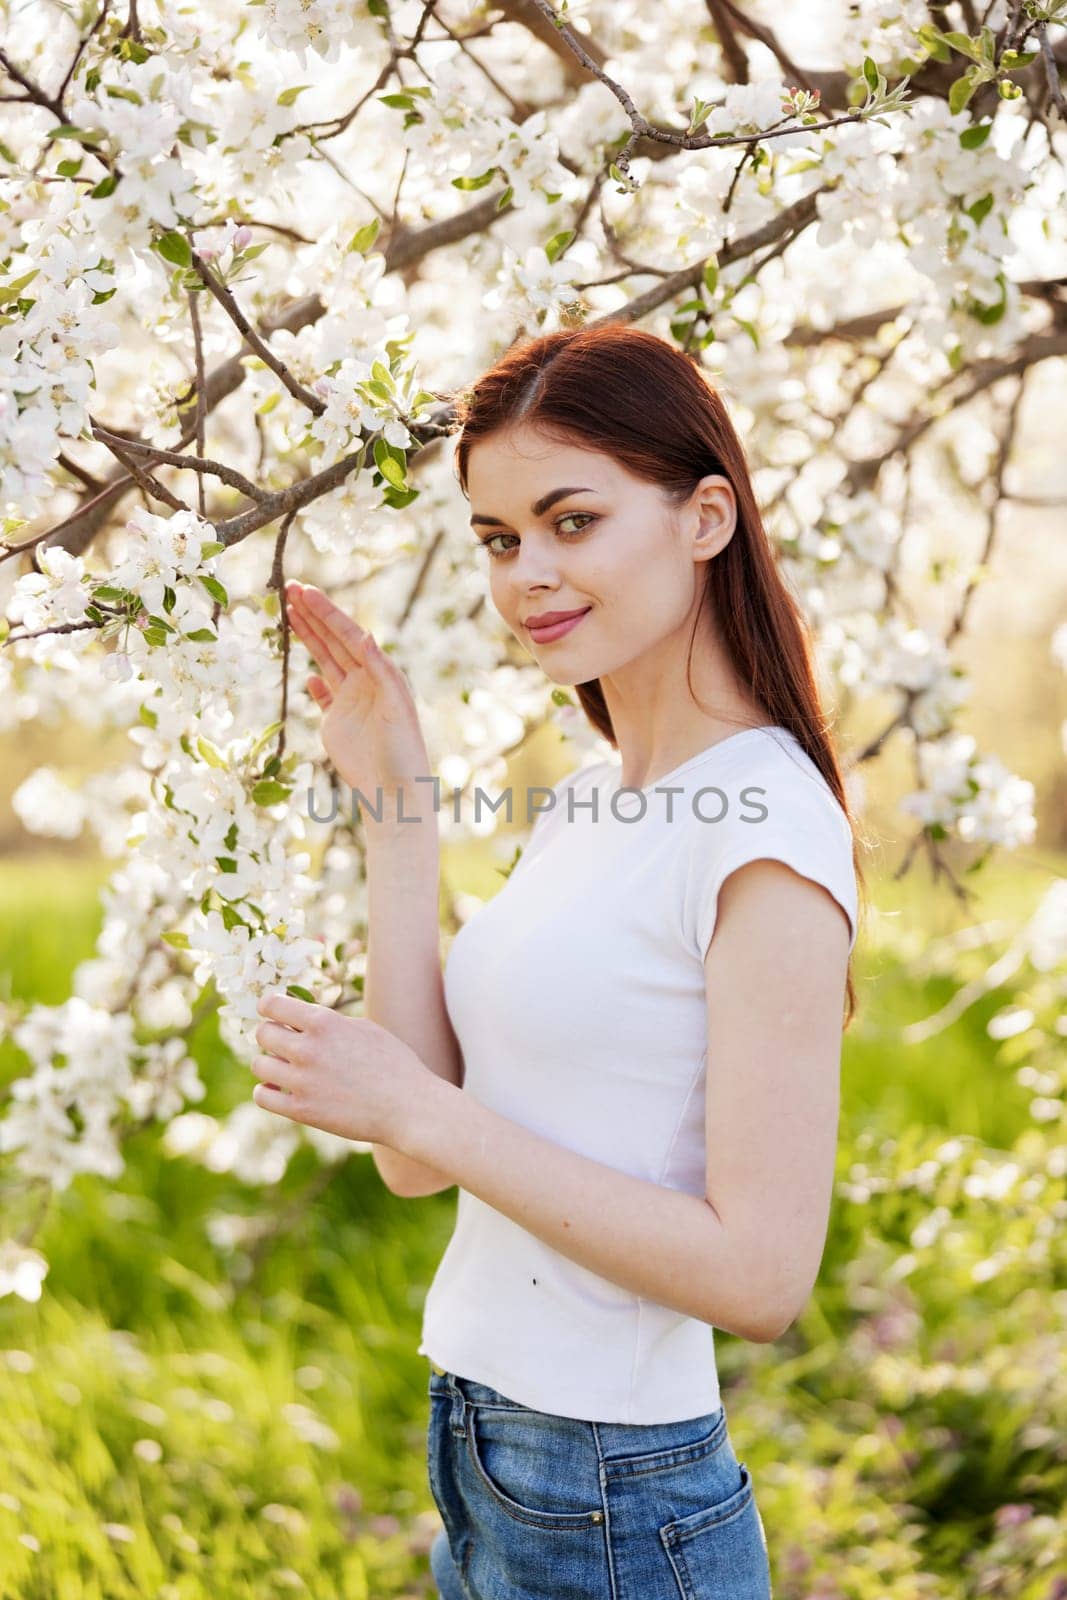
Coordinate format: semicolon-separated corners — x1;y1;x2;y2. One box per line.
467;426;734;685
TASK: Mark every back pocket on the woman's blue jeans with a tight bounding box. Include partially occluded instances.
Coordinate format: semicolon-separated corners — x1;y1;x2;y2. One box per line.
659;1461;771;1600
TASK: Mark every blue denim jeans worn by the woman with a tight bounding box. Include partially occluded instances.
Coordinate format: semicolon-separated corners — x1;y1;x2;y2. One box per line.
427;1366;771;1600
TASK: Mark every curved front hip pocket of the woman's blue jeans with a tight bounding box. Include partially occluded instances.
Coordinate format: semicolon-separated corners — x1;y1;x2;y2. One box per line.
467;1405;605;1533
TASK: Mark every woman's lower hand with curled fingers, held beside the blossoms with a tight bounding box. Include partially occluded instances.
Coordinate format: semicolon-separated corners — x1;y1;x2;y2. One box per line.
251;994;430;1149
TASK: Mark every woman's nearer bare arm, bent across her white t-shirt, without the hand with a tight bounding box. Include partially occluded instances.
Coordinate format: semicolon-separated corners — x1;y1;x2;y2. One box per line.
383;861;849;1342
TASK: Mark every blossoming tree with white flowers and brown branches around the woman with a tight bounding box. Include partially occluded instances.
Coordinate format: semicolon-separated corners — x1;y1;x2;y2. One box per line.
0;0;1067;1299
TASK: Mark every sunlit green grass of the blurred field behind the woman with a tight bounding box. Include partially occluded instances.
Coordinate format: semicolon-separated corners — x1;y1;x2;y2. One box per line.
0;851;1067;1600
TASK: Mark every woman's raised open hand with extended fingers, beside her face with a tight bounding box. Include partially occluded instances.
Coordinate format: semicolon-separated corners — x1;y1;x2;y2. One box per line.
285;581;435;829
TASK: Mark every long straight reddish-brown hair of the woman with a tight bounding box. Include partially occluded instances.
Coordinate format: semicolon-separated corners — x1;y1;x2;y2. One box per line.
454;322;865;1027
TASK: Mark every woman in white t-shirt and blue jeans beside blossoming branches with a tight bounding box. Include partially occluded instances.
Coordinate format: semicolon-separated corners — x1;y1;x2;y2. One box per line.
258;325;861;1600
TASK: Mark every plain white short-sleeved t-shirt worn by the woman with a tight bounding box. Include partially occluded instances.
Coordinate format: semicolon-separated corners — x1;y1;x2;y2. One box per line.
419;726;857;1422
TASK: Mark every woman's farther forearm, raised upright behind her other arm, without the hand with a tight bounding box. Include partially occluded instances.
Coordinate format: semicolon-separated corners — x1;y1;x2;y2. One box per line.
363;819;462;1200
